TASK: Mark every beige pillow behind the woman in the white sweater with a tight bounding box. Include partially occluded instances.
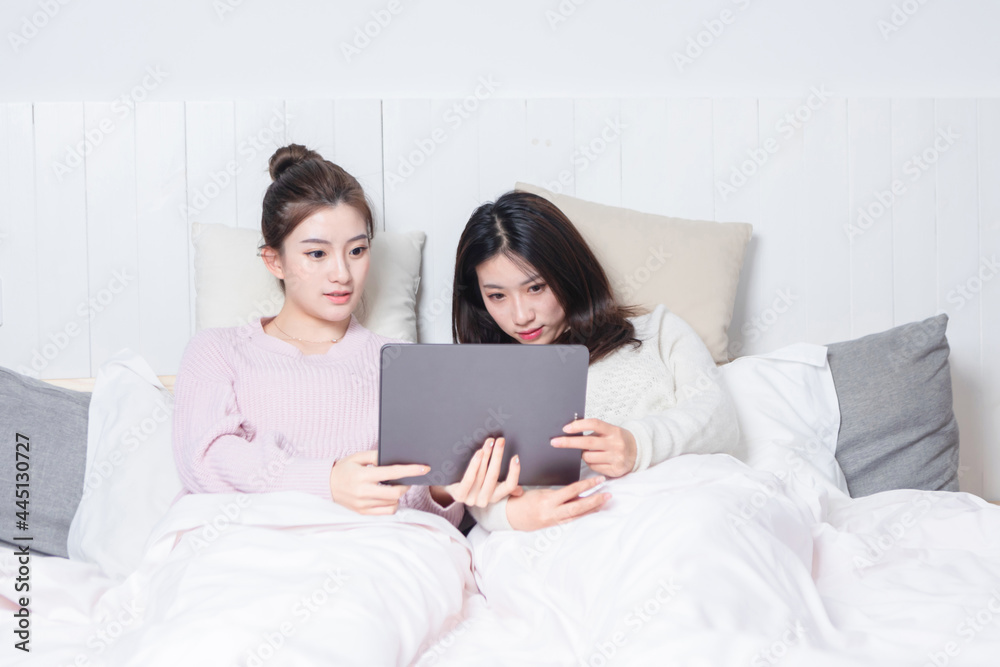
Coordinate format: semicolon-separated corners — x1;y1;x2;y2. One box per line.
515;183;753;363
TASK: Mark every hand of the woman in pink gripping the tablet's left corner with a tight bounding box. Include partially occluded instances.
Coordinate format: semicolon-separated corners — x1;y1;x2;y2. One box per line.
330;449;430;514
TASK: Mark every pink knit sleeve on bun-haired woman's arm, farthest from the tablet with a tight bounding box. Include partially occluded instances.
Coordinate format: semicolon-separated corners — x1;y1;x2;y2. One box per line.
173;329;335;499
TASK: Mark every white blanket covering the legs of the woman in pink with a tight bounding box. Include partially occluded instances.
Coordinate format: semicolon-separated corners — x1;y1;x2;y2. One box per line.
0;492;476;667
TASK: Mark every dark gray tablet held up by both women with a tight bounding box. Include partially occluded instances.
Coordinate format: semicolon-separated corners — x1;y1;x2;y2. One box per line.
378;344;590;486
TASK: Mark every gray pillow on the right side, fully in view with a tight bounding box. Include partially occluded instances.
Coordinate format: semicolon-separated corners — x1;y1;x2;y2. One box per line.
827;314;958;498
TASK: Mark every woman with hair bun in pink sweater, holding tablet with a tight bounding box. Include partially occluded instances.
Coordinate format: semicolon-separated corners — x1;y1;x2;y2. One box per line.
174;144;516;526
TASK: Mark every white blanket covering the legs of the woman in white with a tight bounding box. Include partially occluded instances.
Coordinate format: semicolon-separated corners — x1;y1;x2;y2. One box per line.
417;455;1000;667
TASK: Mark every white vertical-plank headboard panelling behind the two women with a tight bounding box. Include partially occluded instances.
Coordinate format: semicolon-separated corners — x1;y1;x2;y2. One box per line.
0;95;1000;497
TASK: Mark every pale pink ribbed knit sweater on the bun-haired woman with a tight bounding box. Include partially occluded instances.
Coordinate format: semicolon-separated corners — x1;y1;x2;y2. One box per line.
173;315;464;526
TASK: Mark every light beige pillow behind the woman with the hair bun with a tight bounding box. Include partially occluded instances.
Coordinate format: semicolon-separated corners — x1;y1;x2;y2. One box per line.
191;222;426;343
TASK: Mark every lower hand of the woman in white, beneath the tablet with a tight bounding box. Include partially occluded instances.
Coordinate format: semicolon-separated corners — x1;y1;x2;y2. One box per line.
507;477;611;530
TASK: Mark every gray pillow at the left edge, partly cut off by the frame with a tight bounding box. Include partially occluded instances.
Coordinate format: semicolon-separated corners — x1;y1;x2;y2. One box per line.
0;367;90;558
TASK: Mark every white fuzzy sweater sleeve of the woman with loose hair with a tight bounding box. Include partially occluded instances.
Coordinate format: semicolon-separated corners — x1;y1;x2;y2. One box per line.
621;306;739;472
